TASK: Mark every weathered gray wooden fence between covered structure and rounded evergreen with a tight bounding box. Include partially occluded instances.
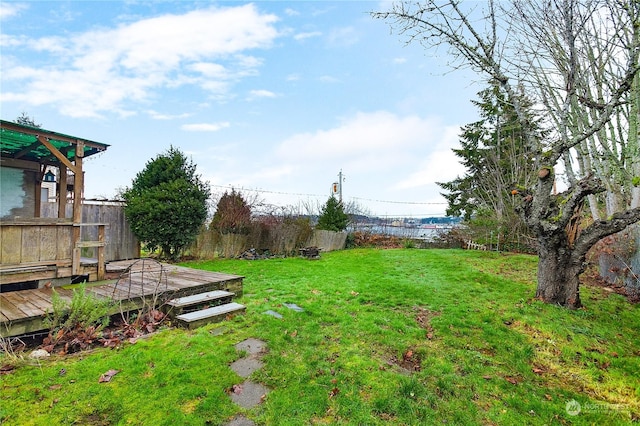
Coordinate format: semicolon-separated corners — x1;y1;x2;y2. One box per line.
40;201;140;262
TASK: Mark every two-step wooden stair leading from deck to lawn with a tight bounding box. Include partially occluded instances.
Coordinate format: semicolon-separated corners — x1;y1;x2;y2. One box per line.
166;290;246;329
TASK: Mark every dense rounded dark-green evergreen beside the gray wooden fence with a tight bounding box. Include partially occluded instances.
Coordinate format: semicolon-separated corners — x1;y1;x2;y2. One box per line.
122;147;210;259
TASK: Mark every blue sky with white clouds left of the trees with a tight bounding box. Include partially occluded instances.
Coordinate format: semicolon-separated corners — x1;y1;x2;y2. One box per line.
0;1;482;217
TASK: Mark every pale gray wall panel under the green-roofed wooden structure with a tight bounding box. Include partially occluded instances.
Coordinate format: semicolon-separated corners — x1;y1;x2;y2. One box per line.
0;166;37;219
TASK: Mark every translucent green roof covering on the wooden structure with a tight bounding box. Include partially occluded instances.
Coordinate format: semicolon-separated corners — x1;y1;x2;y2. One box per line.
0;120;109;165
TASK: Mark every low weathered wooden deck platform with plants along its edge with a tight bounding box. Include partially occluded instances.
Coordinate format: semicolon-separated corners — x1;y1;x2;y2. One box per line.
0;259;244;337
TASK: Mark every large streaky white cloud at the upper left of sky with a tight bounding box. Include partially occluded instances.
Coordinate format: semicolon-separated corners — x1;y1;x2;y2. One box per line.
1;2;279;117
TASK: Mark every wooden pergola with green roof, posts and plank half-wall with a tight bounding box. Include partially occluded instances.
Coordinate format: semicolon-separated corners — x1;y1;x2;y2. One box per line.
0;120;108;284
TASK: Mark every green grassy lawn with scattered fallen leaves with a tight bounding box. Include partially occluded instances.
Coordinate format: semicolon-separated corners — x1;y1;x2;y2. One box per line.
0;249;640;425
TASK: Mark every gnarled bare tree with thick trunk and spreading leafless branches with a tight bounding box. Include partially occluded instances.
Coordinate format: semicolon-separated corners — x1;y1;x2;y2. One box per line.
373;0;640;308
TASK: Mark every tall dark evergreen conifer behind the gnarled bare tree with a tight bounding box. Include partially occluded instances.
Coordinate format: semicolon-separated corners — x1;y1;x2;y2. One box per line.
438;84;541;246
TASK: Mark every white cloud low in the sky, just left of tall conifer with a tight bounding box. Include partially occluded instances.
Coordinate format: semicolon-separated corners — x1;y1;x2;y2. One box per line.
276;111;457;183
